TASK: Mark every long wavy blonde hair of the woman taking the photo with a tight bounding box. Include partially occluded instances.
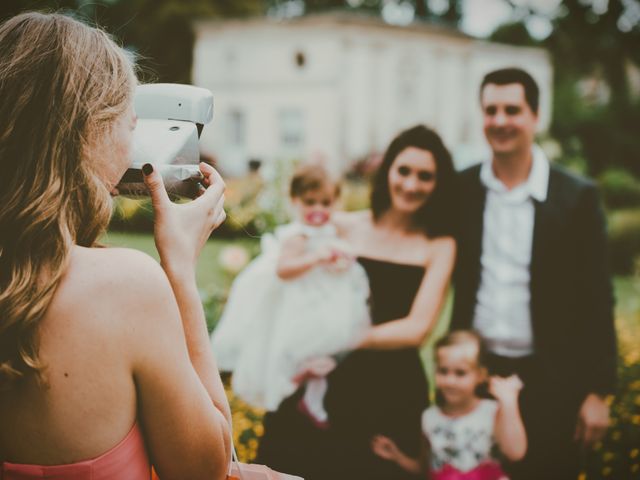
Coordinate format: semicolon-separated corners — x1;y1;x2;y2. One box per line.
0;12;136;390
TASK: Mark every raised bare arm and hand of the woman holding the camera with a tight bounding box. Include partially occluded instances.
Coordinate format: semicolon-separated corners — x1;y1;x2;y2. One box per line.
129;164;231;480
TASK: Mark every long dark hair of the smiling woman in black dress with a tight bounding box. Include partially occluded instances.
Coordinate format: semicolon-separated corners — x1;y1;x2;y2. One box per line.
371;125;457;237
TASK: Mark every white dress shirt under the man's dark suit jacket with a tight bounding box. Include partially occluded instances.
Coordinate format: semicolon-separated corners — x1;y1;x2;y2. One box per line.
473;145;549;357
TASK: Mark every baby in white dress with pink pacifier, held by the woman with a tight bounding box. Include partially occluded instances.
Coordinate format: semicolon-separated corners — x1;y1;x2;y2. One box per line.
212;165;370;425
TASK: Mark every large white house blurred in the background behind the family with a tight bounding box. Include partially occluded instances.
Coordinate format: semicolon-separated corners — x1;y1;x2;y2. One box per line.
193;13;552;173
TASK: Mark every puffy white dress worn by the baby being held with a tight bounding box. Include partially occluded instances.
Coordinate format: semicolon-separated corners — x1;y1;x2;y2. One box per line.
212;223;370;417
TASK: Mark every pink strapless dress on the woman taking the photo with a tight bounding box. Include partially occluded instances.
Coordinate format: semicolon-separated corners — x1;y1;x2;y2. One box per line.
0;423;151;480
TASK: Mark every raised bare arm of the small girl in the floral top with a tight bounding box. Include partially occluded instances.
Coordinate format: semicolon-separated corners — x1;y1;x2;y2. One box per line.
489;375;527;462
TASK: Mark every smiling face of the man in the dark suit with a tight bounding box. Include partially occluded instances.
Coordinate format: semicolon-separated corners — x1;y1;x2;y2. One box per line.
480;83;538;156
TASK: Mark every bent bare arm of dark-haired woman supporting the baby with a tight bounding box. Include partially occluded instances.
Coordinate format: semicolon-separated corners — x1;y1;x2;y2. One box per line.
359;237;456;350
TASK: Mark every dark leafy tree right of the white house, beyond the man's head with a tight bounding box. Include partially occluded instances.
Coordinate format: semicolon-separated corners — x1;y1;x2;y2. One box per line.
492;0;640;176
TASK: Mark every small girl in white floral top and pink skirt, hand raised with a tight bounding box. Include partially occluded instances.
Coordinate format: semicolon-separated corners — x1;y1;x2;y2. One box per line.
372;330;527;480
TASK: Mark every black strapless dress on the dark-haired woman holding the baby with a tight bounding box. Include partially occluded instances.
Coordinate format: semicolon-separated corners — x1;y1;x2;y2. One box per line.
256;258;429;480
